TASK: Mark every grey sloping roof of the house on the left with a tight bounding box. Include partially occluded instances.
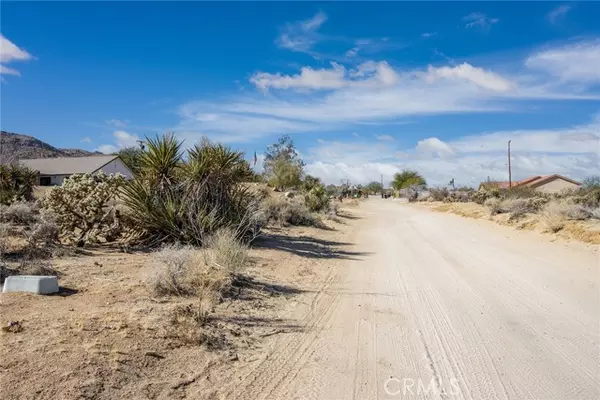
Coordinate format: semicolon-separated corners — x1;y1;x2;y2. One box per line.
20;155;119;175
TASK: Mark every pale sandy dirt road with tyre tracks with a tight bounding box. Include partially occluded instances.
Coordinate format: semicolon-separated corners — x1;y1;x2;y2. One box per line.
230;199;600;400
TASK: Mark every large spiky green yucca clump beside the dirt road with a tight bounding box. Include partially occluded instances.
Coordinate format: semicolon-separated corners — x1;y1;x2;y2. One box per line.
123;135;258;245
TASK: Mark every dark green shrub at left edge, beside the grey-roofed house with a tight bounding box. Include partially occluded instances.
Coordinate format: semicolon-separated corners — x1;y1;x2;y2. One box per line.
0;164;37;204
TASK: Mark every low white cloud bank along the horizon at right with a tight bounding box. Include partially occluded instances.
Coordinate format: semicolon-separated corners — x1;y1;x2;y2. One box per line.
306;114;600;186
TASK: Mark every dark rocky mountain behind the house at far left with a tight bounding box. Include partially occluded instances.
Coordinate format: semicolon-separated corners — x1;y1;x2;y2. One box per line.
0;131;102;163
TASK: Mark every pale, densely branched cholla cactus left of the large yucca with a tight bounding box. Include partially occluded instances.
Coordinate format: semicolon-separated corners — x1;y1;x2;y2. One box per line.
39;172;125;246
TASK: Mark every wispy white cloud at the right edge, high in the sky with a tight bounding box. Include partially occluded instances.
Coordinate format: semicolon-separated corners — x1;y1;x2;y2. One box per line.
525;39;600;82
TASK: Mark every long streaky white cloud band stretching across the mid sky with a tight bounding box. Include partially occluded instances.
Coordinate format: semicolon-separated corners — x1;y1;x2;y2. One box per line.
173;40;600;142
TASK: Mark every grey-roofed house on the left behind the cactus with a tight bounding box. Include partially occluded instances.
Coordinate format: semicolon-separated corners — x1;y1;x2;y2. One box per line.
20;155;133;186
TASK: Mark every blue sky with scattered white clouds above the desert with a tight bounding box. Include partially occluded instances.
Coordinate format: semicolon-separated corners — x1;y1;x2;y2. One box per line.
0;2;600;185
